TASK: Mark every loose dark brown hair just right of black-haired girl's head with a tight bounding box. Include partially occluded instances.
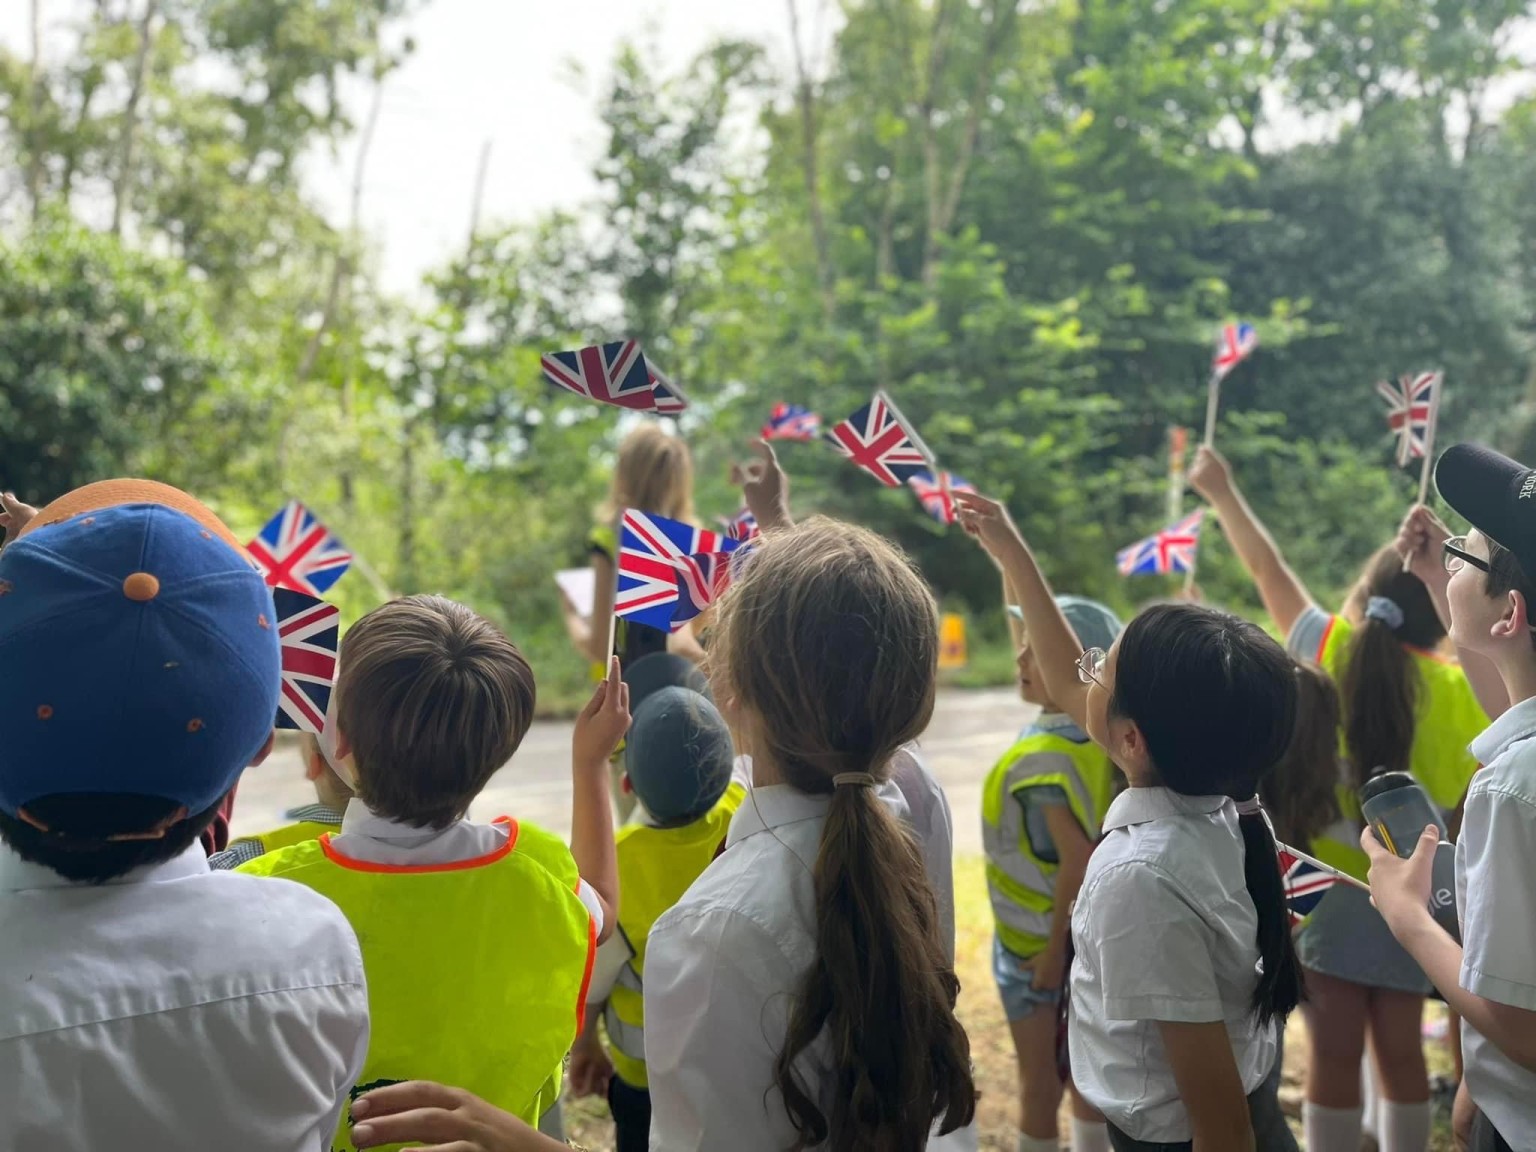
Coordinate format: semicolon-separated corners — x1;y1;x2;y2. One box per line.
1258;662;1341;849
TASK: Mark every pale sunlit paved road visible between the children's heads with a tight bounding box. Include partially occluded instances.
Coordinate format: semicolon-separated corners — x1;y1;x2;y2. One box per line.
233;690;1029;854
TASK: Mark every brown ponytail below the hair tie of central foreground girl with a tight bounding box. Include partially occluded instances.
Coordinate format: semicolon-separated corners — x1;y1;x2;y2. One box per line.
774;785;975;1152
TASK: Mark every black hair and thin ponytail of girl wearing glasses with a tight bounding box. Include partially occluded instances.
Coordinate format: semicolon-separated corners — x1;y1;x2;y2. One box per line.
1109;604;1303;1025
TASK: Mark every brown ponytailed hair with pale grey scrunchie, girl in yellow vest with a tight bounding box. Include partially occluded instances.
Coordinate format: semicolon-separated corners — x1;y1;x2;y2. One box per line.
1339;547;1445;786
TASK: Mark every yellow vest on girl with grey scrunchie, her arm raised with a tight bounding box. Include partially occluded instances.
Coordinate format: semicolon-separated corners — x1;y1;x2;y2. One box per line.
1312;616;1488;880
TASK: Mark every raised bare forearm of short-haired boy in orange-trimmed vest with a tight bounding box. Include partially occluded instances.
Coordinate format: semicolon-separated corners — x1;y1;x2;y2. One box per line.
571;656;630;943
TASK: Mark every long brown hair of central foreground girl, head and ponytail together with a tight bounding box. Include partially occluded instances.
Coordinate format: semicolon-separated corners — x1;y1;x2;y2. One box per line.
711;518;975;1152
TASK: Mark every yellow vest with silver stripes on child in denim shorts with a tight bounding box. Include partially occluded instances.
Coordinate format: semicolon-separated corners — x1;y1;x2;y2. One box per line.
982;716;1115;958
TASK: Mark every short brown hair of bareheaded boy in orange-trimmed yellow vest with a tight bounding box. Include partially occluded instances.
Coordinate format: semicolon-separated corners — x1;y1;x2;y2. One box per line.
336;596;536;828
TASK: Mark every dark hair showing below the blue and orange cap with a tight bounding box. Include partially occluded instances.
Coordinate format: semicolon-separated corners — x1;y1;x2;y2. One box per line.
0;793;224;883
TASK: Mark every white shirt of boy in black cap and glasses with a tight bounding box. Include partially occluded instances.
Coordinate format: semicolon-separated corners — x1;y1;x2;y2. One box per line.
1456;699;1536;1152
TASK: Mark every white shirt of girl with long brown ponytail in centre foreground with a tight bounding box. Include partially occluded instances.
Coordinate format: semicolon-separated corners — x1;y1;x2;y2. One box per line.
645;785;958;1152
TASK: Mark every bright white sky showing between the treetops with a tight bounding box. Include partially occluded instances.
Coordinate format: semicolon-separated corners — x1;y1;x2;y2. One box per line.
0;0;811;292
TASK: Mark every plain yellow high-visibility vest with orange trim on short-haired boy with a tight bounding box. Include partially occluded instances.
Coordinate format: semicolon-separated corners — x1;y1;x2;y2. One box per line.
240;817;598;1152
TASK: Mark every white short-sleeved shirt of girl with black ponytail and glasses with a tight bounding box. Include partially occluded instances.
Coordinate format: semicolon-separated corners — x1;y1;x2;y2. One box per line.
1069;788;1276;1143
